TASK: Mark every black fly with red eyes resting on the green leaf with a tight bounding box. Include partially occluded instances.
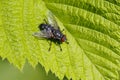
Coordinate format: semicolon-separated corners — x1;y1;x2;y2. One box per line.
33;12;68;51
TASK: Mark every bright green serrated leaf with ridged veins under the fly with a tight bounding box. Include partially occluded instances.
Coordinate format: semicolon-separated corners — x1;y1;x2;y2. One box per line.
0;0;120;80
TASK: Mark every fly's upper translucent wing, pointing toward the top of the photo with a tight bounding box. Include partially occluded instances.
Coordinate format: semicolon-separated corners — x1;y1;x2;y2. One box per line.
47;11;60;30
